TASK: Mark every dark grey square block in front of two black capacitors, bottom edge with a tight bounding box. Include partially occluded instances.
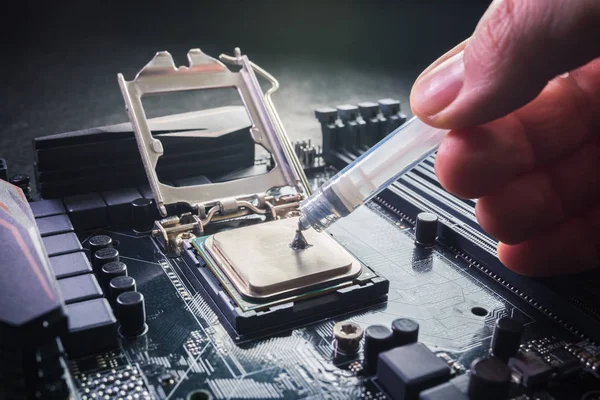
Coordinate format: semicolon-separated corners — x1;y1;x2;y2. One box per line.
377;343;450;400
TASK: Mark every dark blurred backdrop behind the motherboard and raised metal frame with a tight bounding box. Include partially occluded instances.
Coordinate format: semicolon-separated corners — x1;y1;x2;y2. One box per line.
0;0;489;184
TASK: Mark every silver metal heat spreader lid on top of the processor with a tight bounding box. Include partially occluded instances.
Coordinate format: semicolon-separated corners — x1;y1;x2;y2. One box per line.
206;218;361;300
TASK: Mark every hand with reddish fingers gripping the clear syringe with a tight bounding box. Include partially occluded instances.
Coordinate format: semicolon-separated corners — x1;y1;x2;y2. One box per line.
411;0;600;276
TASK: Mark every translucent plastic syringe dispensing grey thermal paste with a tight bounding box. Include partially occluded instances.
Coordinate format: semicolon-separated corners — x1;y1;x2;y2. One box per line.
291;117;448;248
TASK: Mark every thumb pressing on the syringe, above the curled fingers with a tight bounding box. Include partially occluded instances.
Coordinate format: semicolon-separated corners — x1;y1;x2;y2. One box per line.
411;0;600;129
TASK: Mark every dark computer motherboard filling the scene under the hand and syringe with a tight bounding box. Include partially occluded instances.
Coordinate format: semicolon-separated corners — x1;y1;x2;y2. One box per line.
0;50;600;400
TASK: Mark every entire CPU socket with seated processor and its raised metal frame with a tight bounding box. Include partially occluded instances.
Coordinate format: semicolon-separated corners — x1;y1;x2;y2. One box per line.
119;49;389;340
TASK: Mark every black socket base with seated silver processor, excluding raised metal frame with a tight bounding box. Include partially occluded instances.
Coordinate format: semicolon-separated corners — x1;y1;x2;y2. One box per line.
185;214;389;341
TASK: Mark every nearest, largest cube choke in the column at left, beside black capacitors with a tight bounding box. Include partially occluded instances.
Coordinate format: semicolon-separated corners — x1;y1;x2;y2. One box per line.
66;299;119;357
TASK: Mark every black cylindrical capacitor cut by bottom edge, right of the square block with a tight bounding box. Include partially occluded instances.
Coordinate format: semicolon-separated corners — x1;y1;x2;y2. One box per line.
468;357;510;400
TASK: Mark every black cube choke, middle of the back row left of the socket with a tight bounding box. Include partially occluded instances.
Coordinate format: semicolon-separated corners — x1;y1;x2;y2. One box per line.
63;193;108;230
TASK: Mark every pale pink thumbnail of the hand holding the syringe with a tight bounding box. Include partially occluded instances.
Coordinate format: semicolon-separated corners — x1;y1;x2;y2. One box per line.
411;51;465;116
